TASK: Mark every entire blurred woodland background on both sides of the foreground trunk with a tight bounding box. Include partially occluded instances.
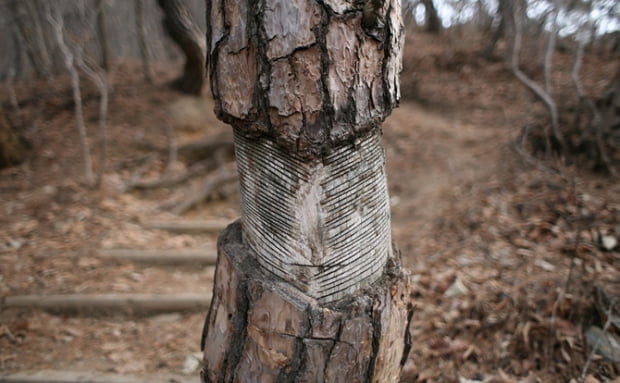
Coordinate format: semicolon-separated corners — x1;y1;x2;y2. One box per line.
0;0;620;383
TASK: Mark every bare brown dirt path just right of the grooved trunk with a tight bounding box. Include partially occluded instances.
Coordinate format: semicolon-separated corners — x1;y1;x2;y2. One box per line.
384;102;509;260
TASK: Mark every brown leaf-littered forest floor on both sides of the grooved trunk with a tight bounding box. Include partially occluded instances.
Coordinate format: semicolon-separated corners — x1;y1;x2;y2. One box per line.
0;29;620;383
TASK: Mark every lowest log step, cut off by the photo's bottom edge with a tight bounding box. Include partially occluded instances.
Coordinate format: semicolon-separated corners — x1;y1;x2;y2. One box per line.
0;370;199;383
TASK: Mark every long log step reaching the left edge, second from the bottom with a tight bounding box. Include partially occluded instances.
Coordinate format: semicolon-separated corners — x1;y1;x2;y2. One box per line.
0;293;211;314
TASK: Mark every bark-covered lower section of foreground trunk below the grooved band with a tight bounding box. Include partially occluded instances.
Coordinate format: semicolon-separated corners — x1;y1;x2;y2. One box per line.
201;222;413;383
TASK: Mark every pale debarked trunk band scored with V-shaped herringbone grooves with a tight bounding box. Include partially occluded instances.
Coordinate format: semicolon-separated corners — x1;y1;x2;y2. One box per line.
235;134;392;302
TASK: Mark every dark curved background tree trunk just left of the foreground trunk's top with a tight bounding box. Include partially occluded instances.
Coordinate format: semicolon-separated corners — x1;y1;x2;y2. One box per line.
158;0;206;95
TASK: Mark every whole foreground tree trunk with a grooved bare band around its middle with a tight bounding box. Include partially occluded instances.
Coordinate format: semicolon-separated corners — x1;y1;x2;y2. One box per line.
202;0;413;382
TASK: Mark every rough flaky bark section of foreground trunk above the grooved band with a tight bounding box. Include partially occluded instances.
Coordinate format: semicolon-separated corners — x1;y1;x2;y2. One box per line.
207;0;404;158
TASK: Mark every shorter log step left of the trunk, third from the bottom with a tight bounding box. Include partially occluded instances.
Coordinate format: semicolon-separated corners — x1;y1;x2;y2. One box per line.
97;249;217;265
